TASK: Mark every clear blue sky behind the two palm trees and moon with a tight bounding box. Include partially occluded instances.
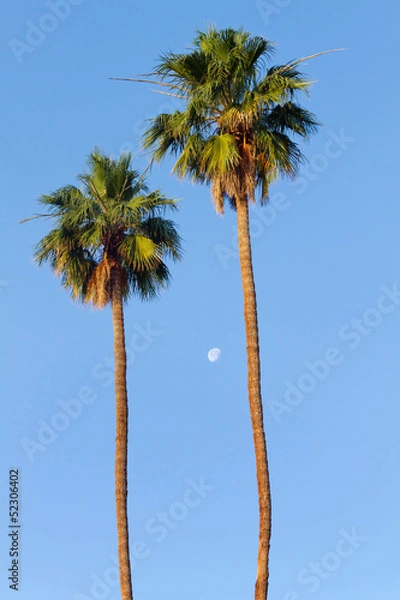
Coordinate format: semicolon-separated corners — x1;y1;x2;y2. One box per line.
0;0;400;600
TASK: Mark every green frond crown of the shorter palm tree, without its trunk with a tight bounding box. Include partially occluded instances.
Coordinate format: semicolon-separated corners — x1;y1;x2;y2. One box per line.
34;149;181;308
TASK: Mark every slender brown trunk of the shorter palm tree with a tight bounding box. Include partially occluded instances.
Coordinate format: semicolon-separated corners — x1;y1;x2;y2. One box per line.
111;267;133;600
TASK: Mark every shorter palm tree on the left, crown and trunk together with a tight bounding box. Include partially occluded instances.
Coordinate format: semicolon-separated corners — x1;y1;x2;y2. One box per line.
27;150;181;600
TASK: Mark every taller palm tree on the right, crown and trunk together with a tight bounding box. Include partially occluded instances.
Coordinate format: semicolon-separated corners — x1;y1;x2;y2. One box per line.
139;28;322;600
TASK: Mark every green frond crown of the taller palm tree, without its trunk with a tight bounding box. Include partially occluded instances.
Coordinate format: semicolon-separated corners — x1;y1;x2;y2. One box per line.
144;27;318;212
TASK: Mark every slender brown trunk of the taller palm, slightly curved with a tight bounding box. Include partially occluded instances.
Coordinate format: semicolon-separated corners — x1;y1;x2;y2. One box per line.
237;199;271;600
